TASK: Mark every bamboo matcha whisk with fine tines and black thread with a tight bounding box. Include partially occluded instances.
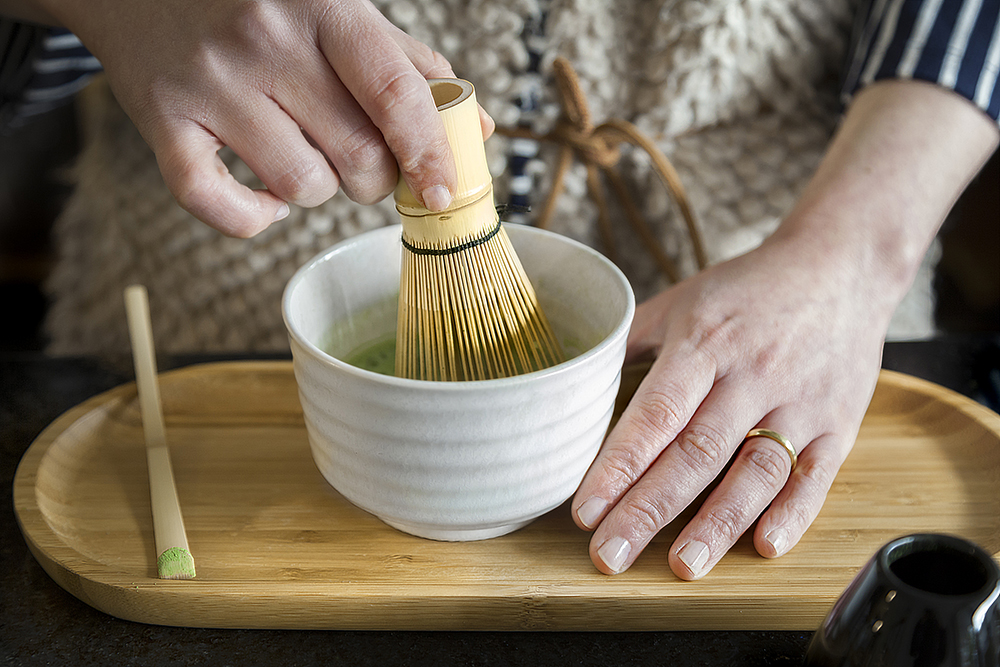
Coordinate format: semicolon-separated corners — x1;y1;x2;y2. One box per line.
395;79;562;380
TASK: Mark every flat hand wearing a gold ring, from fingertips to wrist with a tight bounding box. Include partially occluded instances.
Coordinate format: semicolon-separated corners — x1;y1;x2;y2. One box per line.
573;232;891;579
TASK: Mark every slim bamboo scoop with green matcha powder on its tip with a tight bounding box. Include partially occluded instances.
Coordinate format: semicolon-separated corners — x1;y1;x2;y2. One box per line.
125;285;195;579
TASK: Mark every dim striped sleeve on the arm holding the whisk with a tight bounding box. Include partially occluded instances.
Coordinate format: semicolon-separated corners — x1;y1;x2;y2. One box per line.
0;19;101;128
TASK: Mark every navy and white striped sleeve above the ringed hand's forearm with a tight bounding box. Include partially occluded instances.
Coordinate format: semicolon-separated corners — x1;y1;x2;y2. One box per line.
843;0;1000;120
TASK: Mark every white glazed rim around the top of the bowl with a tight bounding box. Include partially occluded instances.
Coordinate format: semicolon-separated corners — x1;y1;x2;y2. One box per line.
281;223;635;391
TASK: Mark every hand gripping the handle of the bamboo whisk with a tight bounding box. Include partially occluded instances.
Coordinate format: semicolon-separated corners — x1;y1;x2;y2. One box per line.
45;0;492;236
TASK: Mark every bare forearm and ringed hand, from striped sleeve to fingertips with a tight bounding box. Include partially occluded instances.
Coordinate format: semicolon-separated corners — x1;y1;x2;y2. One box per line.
573;81;1000;579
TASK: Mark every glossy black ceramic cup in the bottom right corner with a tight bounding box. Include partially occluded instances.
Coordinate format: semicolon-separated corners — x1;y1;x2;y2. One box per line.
806;534;1000;667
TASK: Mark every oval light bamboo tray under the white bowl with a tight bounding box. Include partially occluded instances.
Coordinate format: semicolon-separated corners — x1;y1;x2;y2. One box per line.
14;362;1000;630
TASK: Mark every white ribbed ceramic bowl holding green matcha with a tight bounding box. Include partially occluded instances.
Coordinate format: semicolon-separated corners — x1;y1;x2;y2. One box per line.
282;226;635;540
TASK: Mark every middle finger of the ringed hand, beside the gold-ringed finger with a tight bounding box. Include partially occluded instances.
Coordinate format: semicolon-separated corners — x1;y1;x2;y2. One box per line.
576;378;761;574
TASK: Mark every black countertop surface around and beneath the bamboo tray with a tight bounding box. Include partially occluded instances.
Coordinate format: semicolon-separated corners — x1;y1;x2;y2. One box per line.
0;334;1000;666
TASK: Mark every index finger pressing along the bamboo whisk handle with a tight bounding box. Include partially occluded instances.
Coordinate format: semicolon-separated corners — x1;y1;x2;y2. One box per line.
320;3;456;211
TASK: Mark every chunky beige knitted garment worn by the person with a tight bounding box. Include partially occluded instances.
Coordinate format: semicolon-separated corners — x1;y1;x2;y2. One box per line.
46;0;933;354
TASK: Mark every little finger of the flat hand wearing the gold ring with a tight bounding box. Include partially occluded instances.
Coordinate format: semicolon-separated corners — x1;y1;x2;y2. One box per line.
754;434;855;558
